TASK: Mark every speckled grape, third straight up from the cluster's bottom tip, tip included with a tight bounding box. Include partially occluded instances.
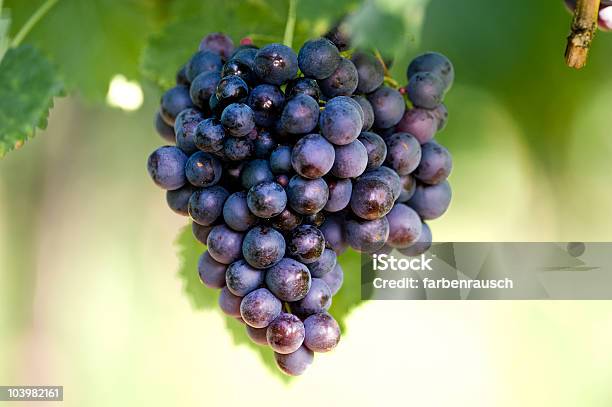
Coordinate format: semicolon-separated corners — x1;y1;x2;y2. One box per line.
266;258;310;302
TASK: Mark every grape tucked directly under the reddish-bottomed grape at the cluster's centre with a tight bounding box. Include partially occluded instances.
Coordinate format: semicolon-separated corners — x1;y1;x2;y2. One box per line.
287;175;329;215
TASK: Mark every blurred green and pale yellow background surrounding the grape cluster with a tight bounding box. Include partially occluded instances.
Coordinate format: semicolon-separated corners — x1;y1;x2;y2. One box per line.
0;0;612;407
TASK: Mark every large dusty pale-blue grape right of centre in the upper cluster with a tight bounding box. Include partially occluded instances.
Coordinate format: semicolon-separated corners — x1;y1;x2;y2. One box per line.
319;99;363;145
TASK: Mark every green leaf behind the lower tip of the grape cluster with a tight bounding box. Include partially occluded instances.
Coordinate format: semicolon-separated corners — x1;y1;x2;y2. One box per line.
176;225;361;382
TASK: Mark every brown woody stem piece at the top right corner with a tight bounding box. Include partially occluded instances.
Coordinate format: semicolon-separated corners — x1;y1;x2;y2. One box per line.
565;0;600;69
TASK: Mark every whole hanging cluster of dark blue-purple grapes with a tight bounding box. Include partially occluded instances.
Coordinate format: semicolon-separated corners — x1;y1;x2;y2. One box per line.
148;32;454;375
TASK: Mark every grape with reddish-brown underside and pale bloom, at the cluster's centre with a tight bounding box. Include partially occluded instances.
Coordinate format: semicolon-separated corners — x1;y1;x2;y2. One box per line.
291;134;335;179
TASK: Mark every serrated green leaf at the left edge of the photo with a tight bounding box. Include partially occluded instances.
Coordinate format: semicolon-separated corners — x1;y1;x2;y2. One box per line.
0;46;63;157
